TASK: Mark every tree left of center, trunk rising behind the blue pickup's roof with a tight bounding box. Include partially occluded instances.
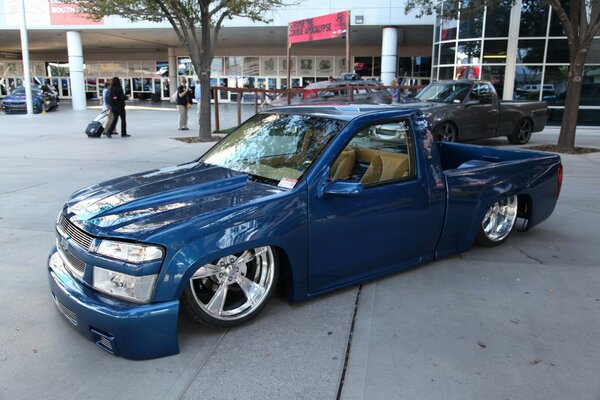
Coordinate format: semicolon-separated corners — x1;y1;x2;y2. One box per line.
74;0;287;141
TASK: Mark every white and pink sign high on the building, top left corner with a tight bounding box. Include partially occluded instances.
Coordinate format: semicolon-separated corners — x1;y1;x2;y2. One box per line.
4;0;104;26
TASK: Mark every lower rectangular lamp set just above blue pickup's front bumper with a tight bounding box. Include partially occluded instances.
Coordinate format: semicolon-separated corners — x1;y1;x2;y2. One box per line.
93;267;157;303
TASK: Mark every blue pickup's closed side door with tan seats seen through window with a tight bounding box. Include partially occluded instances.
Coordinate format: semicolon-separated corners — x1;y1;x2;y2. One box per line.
308;119;435;292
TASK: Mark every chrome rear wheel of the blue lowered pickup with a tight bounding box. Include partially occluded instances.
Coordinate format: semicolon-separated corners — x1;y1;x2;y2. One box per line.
476;196;519;247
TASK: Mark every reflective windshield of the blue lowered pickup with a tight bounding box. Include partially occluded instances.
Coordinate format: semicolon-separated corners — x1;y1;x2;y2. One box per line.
200;114;344;187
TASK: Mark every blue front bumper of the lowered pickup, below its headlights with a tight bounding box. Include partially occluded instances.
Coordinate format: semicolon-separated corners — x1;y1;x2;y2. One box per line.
48;247;179;360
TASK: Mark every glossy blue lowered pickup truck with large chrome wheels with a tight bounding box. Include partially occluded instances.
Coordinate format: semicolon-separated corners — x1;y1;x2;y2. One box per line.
48;106;562;359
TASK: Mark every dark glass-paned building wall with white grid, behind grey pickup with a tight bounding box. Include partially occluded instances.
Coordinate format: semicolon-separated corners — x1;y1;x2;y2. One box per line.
432;0;600;124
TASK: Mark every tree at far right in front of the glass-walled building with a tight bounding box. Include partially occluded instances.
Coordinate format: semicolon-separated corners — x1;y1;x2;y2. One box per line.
405;0;600;153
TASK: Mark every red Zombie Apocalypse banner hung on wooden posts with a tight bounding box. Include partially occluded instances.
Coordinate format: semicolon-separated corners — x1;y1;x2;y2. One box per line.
288;11;348;43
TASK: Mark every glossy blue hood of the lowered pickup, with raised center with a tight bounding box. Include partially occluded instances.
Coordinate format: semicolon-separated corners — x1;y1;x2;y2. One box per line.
66;161;282;240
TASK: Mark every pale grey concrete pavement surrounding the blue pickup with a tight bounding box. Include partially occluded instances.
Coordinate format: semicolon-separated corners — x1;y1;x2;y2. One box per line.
0;106;600;400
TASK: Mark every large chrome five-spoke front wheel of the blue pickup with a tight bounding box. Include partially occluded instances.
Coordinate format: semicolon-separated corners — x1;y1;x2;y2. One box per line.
181;246;279;328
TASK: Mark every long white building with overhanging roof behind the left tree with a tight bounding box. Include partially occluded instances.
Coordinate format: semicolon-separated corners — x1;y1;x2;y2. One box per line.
0;0;433;101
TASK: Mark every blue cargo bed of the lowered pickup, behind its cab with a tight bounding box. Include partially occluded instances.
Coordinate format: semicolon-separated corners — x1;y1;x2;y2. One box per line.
436;142;561;257
